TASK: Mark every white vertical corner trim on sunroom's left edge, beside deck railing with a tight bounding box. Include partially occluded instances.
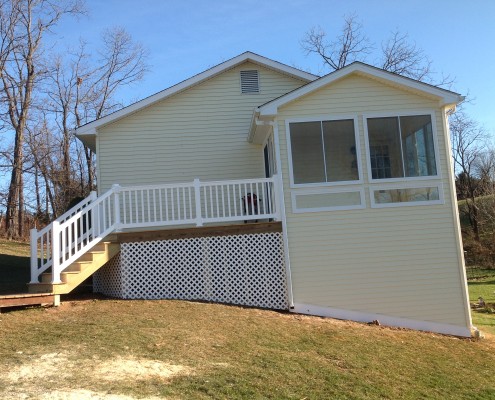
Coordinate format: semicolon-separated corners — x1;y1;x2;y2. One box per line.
273;119;294;309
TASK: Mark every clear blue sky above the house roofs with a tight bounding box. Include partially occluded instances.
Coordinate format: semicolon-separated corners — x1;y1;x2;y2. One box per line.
57;0;495;136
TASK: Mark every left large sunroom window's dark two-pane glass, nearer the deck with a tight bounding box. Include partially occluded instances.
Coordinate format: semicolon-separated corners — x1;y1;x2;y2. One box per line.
289;119;359;184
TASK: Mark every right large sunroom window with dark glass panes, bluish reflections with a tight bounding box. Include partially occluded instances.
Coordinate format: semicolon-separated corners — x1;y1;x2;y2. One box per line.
367;115;437;179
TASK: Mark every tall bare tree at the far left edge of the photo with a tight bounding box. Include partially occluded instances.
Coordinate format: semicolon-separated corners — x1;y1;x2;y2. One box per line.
0;0;82;238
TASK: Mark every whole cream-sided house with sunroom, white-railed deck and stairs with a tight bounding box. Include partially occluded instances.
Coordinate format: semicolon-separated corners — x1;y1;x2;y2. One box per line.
31;52;471;336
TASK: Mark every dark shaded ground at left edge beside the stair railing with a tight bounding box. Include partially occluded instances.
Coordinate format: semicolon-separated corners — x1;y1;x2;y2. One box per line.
0;254;30;294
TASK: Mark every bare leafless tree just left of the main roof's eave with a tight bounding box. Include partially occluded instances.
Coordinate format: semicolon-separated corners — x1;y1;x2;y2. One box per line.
47;28;147;198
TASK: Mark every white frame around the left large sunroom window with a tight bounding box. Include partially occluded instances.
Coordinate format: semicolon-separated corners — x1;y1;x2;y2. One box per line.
285;114;364;189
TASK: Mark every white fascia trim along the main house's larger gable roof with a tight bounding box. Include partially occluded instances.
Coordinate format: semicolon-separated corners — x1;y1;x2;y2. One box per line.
76;52;318;136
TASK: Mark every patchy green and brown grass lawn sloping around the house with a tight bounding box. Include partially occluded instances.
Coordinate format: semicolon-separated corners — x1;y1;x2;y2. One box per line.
0;242;495;400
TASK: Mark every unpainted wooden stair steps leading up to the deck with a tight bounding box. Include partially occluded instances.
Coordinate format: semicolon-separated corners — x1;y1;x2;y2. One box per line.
29;242;120;295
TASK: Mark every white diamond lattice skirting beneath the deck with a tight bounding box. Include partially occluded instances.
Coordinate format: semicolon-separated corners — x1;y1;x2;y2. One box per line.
94;232;288;309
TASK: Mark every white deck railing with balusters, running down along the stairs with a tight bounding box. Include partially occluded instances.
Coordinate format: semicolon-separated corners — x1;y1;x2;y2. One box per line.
31;176;280;283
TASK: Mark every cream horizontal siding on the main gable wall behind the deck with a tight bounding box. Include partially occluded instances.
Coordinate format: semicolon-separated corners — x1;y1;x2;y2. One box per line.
97;63;304;193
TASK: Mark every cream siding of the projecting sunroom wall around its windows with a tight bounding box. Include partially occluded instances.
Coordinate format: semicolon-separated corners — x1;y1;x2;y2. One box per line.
278;76;469;327
